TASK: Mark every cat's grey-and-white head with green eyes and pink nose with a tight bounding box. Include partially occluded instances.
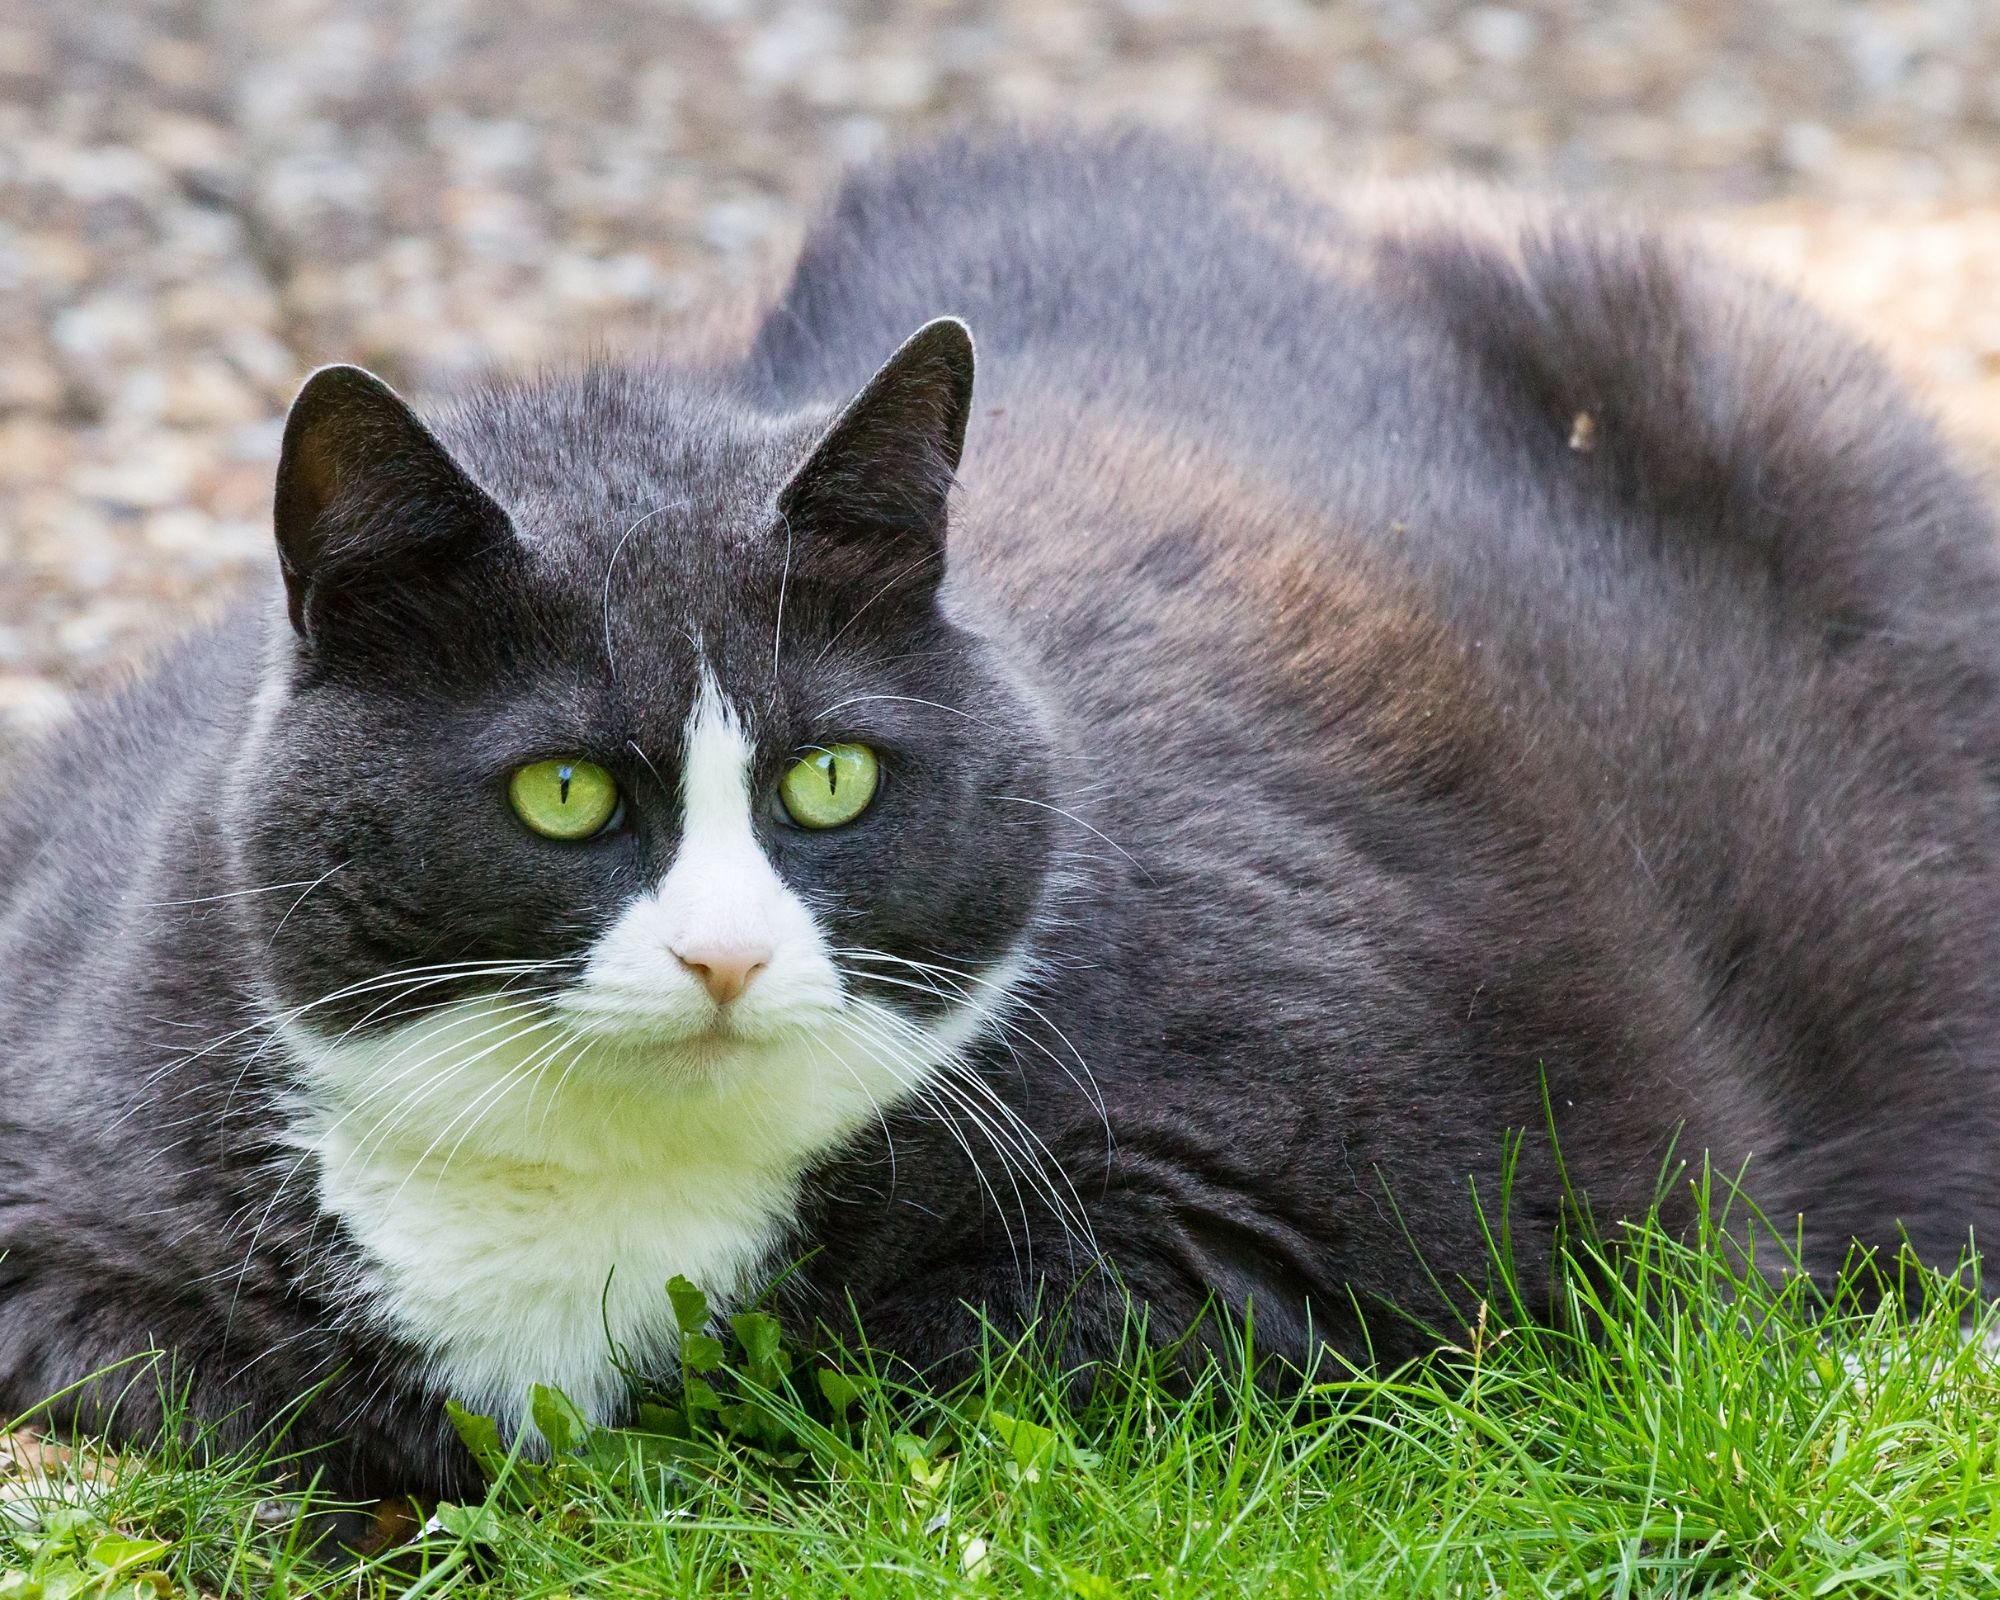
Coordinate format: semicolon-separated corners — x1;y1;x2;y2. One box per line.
234;320;1050;1120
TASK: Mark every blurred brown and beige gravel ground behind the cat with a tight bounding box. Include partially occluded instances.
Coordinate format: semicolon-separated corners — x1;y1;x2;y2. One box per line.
0;0;2000;752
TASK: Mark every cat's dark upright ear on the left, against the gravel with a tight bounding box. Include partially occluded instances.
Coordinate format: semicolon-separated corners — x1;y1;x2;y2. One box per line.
274;366;512;640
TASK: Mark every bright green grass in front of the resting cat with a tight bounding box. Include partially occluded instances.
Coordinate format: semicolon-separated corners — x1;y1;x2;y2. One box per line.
0;1184;2000;1600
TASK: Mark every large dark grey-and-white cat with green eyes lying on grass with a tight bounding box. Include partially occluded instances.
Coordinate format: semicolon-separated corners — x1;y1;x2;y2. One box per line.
0;132;2000;1496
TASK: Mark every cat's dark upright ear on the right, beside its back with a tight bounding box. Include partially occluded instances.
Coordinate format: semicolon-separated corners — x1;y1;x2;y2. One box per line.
778;316;972;594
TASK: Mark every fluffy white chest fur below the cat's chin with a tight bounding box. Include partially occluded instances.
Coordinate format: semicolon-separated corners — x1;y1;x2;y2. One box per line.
292;1000;1000;1418
